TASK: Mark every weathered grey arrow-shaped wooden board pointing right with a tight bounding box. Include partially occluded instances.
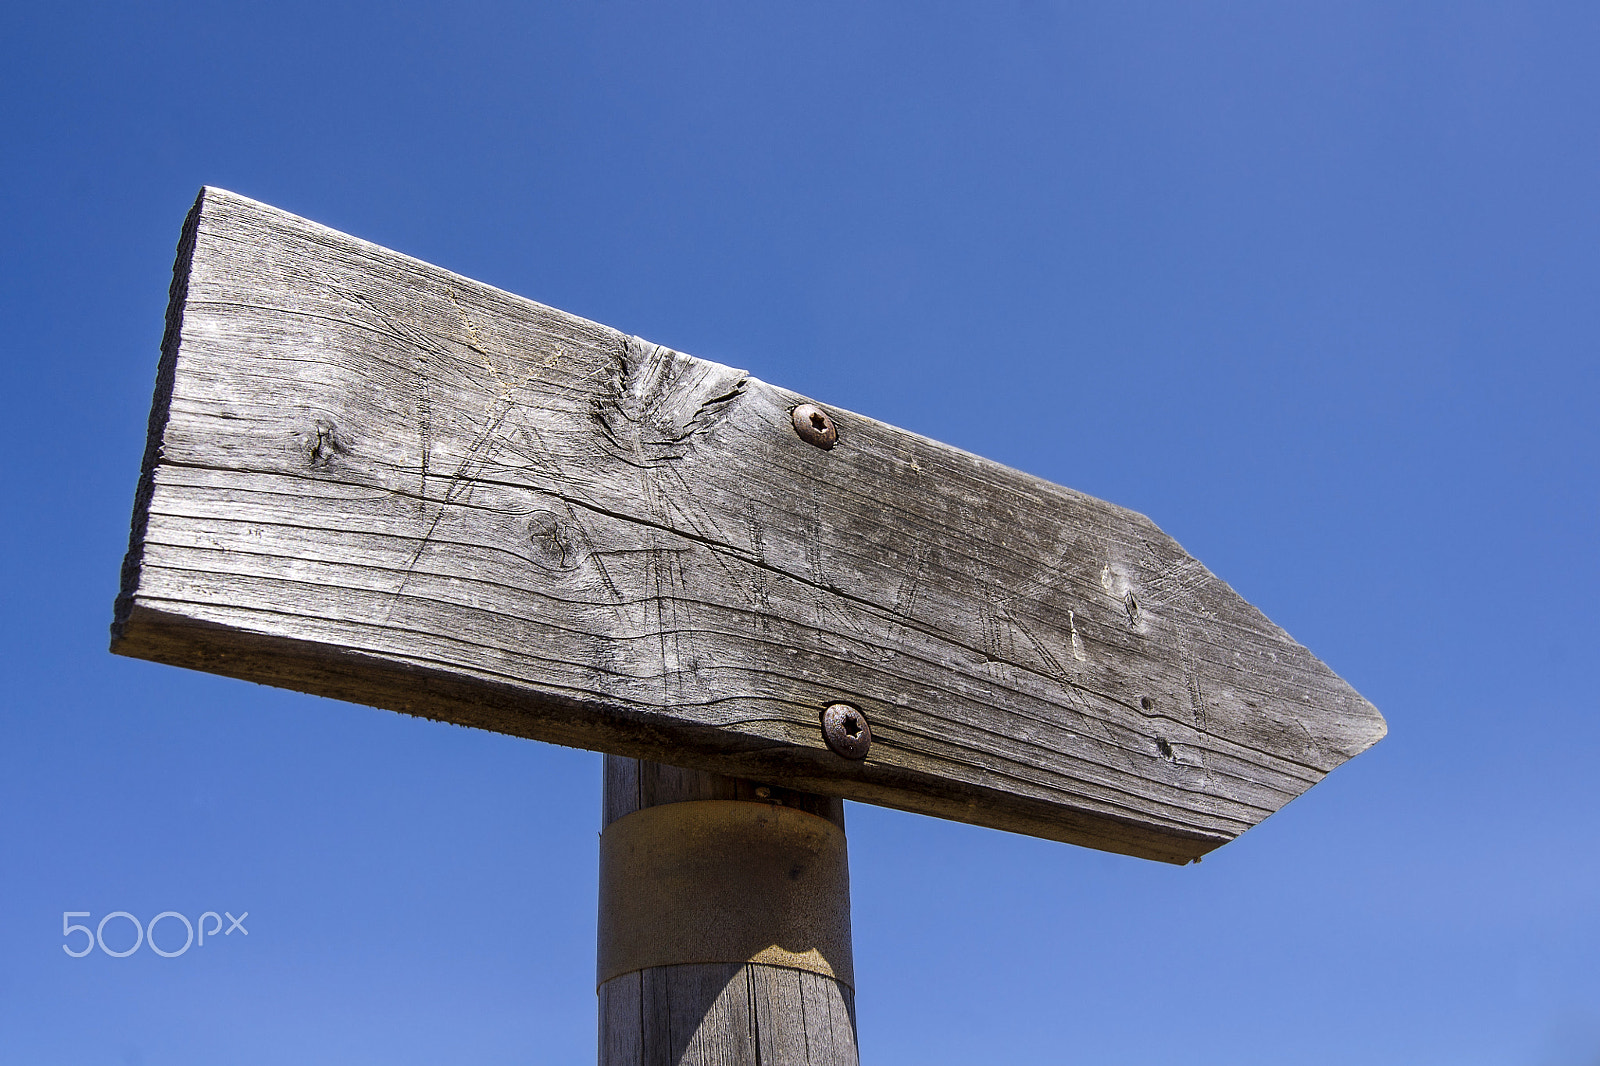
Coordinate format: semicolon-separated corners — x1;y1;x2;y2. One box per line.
112;189;1386;863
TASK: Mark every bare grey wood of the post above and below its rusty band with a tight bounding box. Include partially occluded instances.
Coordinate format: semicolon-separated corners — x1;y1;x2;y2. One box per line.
600;755;858;1066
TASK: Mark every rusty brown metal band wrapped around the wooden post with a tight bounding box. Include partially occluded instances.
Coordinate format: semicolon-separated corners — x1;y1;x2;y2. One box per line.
597;800;856;988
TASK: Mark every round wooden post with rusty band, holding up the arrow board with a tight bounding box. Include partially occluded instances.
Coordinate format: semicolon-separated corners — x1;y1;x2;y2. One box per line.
598;755;858;1066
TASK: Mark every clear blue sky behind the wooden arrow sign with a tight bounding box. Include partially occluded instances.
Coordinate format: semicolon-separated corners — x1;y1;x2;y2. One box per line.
0;0;1600;1066
